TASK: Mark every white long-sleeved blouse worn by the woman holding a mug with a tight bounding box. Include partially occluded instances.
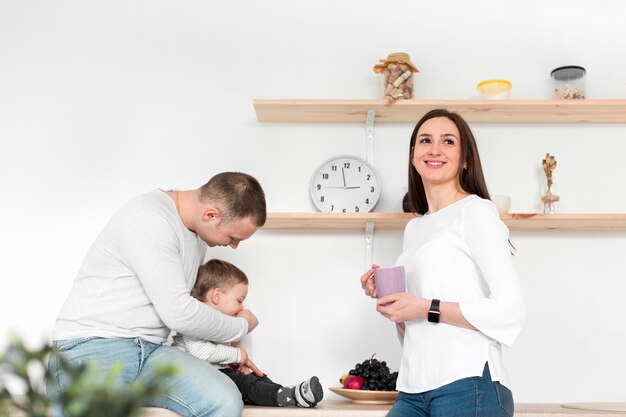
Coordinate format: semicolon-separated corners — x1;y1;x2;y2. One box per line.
397;195;526;393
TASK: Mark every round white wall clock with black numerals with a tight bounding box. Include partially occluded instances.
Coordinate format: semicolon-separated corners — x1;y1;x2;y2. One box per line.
311;156;380;213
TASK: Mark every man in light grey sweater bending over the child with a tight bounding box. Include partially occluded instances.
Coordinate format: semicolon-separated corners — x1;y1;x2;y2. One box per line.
49;172;266;417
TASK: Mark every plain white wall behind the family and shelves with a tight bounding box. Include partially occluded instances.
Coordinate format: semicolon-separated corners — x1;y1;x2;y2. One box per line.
0;0;626;402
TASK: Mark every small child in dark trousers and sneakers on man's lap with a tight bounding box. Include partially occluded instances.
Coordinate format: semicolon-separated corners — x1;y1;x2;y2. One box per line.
174;259;324;407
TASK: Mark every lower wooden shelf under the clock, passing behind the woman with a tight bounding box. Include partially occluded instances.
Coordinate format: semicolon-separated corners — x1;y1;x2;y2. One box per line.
263;213;626;231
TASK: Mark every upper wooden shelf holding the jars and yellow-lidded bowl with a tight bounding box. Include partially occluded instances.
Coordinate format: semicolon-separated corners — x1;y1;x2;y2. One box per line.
254;100;626;123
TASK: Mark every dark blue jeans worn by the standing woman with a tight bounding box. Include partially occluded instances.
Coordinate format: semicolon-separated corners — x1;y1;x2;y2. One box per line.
387;364;513;417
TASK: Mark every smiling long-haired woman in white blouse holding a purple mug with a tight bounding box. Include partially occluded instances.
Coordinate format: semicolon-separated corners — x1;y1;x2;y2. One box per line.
361;109;525;417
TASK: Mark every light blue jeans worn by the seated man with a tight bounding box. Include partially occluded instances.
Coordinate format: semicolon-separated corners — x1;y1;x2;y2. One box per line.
48;337;243;417
